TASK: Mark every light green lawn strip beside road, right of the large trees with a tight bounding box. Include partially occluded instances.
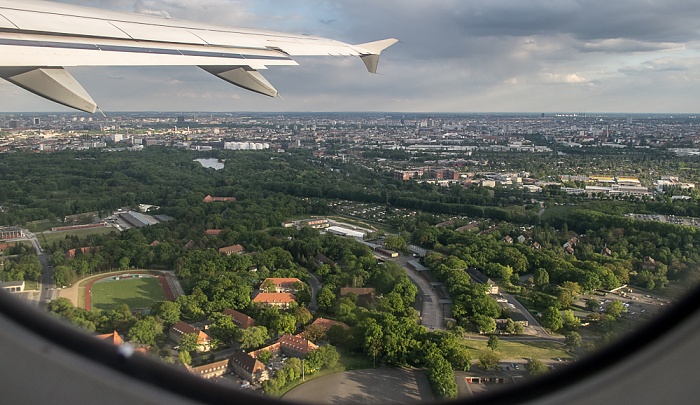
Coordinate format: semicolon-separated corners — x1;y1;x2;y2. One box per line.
463;340;571;360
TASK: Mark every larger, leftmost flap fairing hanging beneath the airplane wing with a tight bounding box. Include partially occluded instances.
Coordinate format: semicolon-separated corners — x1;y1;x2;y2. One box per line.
0;67;97;113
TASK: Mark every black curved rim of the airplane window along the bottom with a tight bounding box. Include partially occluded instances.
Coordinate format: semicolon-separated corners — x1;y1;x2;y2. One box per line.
0;280;700;404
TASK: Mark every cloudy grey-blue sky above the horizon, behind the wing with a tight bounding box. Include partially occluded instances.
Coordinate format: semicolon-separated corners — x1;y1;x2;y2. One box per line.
0;0;700;113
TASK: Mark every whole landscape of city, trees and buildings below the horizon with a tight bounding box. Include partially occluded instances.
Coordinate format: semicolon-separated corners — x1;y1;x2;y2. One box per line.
0;113;700;402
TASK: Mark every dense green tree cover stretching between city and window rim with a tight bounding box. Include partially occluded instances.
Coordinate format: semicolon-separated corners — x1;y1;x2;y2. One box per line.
0;147;700;397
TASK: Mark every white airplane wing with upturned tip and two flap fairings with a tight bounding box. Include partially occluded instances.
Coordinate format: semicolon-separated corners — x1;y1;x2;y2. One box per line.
0;0;397;113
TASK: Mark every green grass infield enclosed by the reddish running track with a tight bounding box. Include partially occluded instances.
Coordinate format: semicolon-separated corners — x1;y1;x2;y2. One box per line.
90;277;165;310
